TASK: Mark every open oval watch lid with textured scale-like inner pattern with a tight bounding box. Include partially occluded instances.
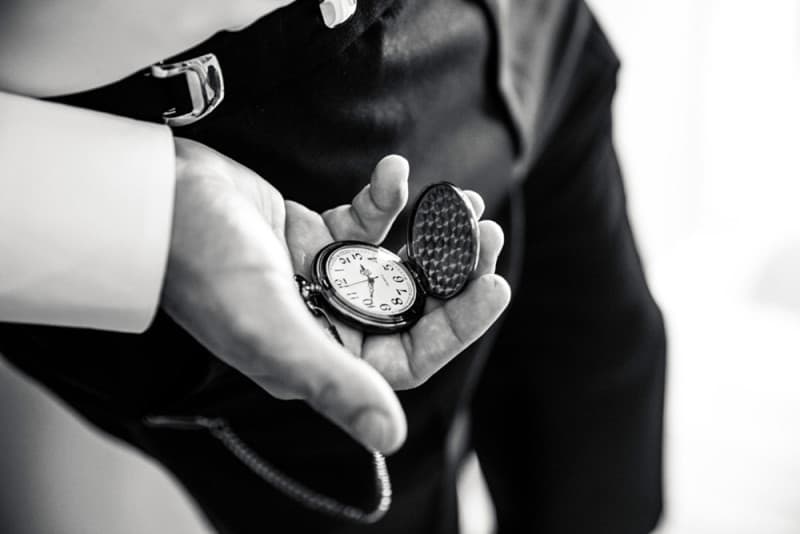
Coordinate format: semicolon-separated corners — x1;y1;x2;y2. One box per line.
408;182;480;299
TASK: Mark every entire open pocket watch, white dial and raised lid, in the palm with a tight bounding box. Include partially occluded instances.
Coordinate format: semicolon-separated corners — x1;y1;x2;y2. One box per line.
295;182;480;339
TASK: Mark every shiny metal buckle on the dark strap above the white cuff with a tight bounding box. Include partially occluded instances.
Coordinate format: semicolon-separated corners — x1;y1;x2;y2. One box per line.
150;54;225;127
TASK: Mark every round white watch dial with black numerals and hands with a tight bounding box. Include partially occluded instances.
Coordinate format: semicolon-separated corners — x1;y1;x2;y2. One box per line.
325;245;417;317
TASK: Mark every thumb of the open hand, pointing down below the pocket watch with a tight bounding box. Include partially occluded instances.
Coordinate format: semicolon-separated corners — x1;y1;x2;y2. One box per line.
230;279;406;453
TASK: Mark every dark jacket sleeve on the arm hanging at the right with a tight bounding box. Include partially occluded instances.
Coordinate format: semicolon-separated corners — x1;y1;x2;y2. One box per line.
472;17;665;534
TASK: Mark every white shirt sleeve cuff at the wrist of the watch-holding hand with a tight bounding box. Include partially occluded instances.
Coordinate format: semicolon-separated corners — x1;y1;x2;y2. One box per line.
0;93;175;332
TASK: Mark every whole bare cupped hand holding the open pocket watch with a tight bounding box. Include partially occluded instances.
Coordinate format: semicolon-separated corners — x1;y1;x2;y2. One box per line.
162;139;509;452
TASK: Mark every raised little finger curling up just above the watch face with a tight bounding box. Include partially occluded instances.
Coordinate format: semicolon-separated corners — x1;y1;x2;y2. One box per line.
322;155;408;244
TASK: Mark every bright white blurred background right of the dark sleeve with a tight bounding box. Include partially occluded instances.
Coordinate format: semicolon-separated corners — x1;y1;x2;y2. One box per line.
592;0;800;534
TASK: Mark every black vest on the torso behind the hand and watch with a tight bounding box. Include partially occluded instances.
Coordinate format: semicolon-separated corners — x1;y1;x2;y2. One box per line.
0;0;588;532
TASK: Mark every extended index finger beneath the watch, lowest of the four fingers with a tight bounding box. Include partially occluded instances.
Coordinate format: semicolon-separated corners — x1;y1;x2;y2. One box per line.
363;274;511;389
